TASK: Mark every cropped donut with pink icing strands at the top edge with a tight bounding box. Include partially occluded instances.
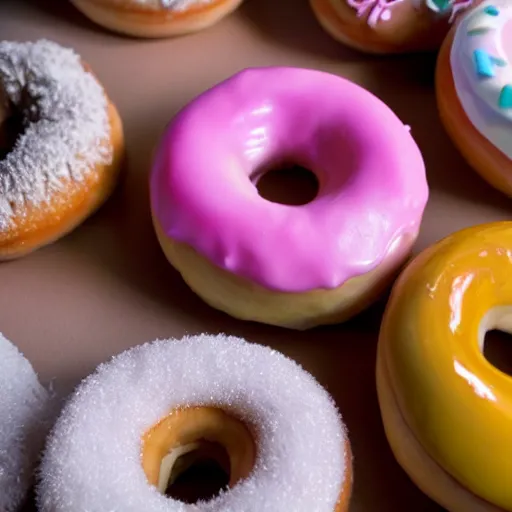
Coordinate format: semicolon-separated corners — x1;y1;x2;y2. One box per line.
310;0;473;54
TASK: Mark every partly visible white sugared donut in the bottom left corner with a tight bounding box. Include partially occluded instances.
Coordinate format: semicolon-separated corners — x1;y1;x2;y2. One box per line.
0;334;51;512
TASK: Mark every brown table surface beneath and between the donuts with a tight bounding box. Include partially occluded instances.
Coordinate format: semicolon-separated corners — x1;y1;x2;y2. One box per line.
0;0;512;512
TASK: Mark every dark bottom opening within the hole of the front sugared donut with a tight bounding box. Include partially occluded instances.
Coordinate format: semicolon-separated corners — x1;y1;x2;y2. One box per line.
164;440;231;504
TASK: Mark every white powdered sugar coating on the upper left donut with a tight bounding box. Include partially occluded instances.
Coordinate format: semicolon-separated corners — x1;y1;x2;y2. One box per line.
0;40;113;232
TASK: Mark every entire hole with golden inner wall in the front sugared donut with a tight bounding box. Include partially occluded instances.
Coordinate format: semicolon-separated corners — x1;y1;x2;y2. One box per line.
142;407;256;504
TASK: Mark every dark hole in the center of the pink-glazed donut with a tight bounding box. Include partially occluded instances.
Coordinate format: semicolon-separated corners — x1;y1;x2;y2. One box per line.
251;162;320;206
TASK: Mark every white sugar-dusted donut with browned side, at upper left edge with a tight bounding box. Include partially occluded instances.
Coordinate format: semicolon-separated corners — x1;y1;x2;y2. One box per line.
0;40;123;260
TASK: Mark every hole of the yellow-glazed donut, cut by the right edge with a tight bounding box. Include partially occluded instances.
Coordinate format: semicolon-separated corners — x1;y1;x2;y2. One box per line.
480;307;512;376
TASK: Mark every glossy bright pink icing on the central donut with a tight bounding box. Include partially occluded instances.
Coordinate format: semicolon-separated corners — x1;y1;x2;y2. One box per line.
150;68;428;292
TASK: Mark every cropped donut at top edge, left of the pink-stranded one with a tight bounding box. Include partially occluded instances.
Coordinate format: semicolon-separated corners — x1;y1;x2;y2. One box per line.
71;0;242;38
